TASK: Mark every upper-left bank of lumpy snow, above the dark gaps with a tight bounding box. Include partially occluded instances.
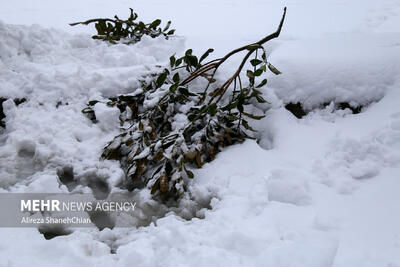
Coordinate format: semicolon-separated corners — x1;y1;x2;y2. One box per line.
0;20;183;100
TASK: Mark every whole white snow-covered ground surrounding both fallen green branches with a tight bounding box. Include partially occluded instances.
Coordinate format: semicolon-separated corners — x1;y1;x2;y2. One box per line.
0;0;400;267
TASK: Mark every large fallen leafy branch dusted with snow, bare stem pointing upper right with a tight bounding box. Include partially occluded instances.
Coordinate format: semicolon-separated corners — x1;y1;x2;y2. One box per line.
76;8;286;200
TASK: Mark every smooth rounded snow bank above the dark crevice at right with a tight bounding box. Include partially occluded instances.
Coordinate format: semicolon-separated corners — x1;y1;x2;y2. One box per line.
270;33;400;109
